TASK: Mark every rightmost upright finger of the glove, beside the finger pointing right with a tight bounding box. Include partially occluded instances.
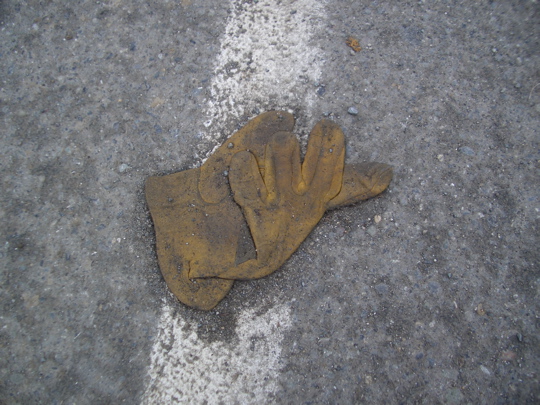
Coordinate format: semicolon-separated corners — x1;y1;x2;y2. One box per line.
302;120;345;201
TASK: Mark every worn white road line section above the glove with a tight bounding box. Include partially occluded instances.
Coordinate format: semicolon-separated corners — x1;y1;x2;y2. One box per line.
205;0;325;147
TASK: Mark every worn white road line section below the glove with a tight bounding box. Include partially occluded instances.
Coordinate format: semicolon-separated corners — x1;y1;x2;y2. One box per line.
143;298;291;404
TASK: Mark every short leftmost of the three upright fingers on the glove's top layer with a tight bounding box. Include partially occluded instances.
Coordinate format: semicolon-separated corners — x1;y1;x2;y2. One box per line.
229;151;267;209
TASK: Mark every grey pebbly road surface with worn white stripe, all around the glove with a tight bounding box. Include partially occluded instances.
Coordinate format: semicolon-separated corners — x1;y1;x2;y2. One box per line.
0;0;540;404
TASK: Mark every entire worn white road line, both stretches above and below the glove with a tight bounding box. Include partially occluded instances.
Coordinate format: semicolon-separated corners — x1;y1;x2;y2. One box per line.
143;0;324;404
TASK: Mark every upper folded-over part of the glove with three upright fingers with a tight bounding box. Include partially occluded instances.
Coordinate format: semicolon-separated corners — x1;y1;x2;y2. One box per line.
189;120;345;280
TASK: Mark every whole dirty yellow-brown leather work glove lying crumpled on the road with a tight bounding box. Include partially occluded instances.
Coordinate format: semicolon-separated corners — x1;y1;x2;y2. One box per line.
146;111;392;310
